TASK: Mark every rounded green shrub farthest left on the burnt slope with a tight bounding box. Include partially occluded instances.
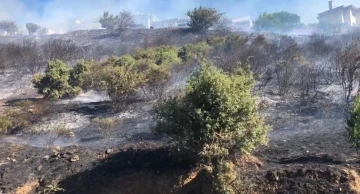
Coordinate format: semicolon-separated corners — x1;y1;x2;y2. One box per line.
32;60;81;99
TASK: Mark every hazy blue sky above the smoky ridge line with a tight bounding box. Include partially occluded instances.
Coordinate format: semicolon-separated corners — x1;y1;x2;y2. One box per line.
0;0;360;33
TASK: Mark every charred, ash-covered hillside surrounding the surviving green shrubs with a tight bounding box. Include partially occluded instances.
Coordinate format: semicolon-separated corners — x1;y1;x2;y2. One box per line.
0;27;360;194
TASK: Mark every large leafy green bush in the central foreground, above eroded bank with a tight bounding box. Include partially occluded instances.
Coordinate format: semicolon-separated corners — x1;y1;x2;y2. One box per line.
154;65;268;193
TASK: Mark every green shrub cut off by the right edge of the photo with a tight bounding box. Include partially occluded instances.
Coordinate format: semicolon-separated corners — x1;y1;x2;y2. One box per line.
347;96;360;149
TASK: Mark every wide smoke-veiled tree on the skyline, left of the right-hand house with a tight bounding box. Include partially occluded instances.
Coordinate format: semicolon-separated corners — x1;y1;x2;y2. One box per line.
254;11;301;32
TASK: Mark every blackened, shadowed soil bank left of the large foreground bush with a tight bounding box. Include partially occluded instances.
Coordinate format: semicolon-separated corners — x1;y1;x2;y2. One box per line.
60;148;195;194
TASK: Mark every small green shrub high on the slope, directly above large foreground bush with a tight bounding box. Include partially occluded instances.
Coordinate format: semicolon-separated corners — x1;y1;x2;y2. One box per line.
178;42;210;62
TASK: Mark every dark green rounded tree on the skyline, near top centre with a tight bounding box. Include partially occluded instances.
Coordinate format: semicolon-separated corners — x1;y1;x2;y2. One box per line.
186;6;224;31
